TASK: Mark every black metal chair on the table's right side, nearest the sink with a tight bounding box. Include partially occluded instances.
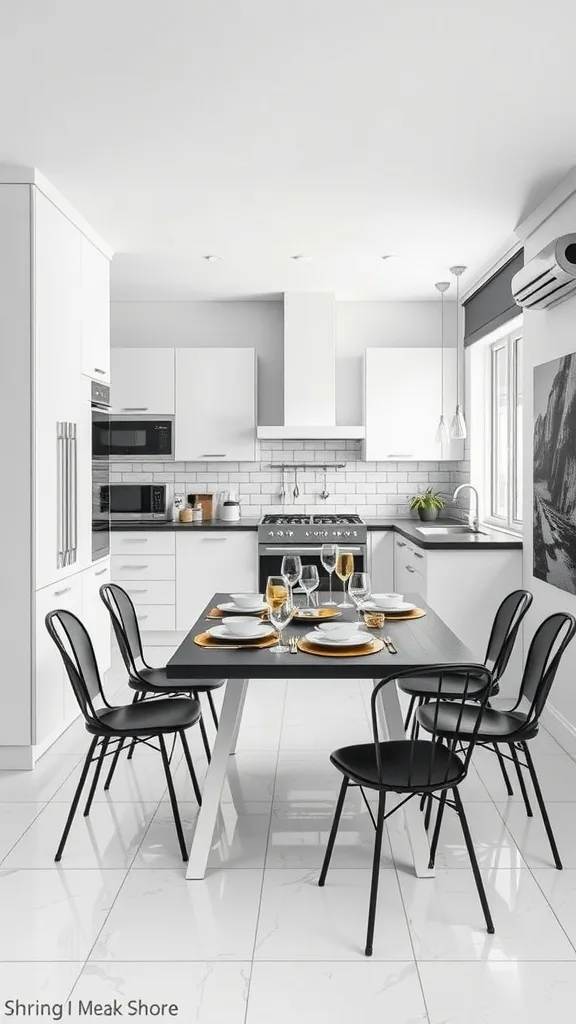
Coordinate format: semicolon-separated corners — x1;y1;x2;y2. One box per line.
399;590;533;806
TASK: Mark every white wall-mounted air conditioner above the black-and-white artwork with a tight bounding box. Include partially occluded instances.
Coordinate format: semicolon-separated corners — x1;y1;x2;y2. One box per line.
511;233;576;309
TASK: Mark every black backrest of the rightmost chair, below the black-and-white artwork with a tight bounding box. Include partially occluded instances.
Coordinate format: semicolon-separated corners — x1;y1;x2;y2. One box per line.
516;611;576;724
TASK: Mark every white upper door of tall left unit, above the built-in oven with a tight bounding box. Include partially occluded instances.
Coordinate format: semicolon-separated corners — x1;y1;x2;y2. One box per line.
81;236;110;383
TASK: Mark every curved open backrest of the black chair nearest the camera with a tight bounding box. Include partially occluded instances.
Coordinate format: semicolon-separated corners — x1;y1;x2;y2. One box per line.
371;665;493;788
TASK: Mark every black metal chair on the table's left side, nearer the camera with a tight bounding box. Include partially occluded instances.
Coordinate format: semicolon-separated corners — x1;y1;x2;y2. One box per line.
45;609;202;861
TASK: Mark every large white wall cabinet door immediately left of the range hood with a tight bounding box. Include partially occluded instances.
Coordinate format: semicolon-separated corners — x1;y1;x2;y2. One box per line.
175;348;256;462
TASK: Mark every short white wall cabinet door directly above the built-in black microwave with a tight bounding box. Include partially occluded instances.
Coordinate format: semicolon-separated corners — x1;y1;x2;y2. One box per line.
111;348;174;416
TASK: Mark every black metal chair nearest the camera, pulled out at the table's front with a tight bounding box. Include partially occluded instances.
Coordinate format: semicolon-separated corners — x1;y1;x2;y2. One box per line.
318;665;494;956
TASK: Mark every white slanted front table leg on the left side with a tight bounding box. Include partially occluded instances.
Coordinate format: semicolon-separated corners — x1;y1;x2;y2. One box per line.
187;679;248;879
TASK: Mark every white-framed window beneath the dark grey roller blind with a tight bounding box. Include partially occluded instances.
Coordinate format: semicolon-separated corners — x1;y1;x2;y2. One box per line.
487;331;522;529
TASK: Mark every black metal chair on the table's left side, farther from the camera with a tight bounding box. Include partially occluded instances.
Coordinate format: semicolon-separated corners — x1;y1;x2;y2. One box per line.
100;583;225;790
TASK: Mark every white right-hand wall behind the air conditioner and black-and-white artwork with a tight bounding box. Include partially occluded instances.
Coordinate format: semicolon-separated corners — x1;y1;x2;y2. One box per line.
524;195;576;746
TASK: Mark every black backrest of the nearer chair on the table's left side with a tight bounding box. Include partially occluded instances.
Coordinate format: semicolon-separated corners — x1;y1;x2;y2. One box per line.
44;608;108;723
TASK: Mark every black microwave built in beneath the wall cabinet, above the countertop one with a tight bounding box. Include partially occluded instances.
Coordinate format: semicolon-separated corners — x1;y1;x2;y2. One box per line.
92;416;174;462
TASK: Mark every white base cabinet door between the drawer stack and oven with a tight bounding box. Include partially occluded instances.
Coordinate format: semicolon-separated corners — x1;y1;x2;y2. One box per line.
176;530;257;630
